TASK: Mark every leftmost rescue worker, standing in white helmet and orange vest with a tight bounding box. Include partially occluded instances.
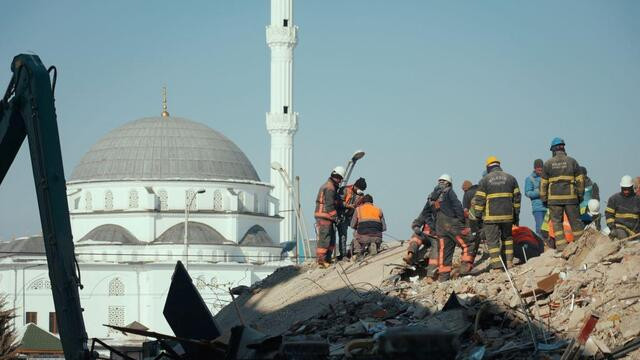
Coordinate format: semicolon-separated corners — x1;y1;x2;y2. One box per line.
313;166;345;268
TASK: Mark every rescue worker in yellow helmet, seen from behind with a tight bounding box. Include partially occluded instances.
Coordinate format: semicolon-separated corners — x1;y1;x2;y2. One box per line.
471;156;521;270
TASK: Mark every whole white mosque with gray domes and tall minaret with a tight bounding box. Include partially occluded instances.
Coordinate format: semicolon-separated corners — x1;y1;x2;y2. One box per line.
0;0;298;342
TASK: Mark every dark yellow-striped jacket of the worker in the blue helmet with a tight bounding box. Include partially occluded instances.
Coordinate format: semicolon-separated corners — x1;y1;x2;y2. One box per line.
540;151;584;205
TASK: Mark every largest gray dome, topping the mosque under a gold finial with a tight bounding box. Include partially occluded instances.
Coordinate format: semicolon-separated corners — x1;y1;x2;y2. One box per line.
70;117;260;181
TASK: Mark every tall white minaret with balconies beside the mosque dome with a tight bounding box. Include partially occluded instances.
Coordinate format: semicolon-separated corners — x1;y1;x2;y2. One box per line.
267;0;298;242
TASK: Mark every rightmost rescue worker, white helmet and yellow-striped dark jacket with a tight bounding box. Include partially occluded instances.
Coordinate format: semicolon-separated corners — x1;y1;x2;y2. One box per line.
604;175;640;239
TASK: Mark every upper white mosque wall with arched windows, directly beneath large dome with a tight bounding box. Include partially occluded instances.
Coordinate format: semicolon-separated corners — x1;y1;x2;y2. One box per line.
67;181;281;242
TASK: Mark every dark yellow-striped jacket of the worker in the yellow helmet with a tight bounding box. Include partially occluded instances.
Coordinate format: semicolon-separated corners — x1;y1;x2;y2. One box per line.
471;166;521;223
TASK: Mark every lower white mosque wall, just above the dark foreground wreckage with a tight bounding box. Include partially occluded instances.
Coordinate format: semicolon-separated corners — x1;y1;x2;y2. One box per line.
0;259;281;339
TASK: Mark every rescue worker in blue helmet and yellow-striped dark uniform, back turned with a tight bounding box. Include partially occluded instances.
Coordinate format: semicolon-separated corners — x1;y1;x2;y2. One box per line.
540;138;584;250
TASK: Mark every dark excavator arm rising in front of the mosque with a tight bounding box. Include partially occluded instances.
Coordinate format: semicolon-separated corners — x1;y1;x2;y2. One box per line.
0;54;95;359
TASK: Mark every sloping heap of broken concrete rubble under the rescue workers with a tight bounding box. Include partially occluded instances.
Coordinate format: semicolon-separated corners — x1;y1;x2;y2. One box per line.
216;231;640;359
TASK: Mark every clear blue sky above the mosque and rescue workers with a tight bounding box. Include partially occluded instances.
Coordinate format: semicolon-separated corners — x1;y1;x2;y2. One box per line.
0;0;640;239
